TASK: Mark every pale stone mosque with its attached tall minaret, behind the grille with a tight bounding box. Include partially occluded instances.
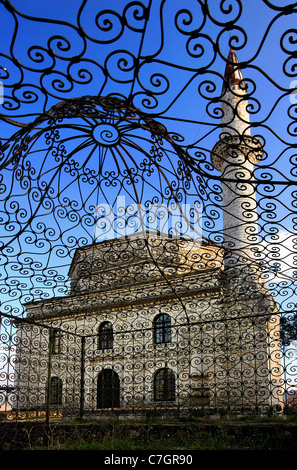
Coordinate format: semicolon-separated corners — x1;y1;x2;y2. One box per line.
17;50;282;412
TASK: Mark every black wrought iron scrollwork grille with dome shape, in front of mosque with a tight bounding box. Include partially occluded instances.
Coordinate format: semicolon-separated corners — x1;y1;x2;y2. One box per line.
0;0;297;421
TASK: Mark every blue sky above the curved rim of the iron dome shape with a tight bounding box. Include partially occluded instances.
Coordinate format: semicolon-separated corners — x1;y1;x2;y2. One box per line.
0;0;296;196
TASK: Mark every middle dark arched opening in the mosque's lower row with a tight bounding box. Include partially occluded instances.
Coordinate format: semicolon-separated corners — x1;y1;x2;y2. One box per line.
97;369;120;408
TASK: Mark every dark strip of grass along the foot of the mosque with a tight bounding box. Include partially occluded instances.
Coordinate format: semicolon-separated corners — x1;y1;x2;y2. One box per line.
3;415;297;451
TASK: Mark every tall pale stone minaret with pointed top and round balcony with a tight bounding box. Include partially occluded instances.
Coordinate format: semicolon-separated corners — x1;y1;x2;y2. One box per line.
211;49;263;287
